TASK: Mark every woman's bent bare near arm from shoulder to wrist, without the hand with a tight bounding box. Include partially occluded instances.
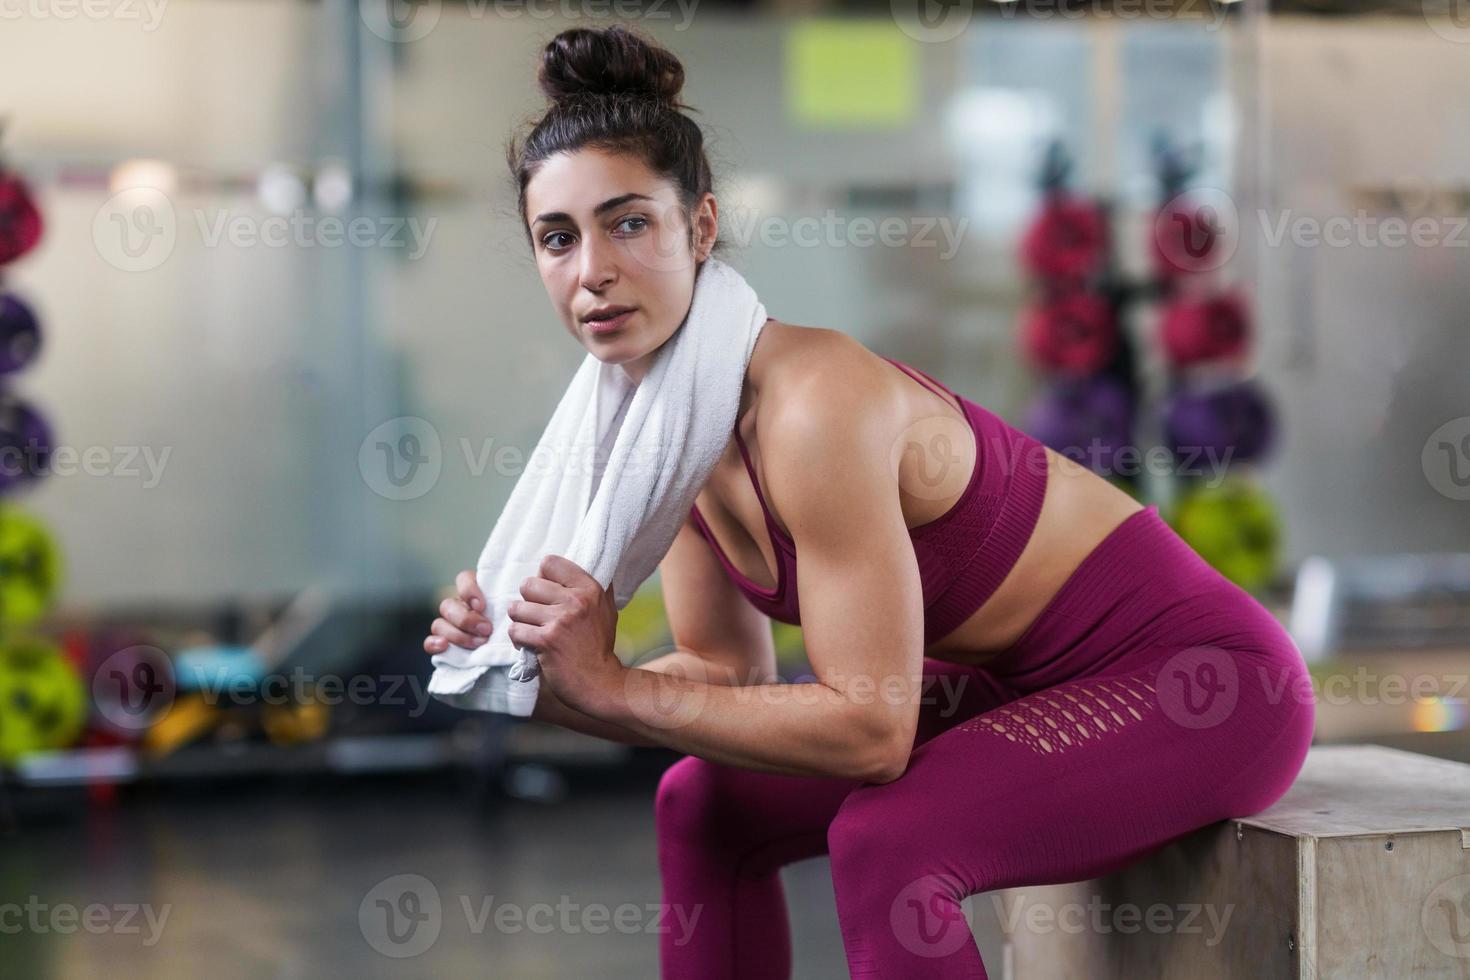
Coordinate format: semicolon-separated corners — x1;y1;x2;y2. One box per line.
588;357;923;782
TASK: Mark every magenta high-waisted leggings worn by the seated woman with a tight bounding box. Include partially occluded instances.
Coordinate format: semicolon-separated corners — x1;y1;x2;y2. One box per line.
654;507;1314;980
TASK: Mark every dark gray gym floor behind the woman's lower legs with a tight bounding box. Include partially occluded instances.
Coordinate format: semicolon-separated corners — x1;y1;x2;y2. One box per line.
0;770;964;980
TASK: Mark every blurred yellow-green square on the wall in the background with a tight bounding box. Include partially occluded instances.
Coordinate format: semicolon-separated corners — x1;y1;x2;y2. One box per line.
786;19;919;128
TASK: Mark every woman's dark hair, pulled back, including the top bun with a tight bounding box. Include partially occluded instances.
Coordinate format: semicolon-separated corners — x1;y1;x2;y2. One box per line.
506;24;723;264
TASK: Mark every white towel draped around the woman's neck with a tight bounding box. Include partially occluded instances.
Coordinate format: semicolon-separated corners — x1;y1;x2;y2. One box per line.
429;257;766;717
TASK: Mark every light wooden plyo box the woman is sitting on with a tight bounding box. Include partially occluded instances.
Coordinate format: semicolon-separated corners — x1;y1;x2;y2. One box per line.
993;745;1470;980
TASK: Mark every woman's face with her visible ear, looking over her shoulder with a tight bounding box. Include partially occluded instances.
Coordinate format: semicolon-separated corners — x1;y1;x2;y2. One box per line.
526;150;716;381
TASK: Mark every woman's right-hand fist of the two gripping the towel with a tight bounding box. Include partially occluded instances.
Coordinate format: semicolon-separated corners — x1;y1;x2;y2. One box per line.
506;555;628;717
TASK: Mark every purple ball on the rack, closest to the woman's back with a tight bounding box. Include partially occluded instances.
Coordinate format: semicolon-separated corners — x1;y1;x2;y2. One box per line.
1026;378;1133;475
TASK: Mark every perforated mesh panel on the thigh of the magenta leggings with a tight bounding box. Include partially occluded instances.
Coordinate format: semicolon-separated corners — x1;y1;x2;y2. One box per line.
958;677;1157;755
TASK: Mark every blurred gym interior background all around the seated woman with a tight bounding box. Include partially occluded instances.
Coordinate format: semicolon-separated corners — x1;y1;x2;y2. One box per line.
0;0;1470;980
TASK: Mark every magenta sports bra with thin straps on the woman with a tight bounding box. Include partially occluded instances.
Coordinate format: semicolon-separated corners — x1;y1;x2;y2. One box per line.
689;348;1047;645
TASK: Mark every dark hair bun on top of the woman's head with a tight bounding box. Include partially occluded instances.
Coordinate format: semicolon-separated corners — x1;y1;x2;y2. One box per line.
539;24;684;107
